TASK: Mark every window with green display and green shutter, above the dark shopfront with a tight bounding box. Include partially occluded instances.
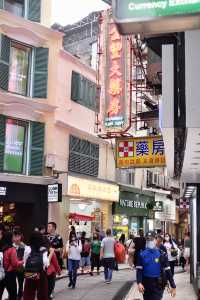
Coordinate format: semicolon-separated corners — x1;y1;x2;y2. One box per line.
0;115;45;176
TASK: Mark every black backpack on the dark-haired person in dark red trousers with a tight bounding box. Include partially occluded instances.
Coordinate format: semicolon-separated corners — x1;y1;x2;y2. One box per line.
25;250;43;277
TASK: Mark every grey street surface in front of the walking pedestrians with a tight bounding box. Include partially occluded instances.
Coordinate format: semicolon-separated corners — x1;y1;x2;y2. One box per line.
55;270;135;300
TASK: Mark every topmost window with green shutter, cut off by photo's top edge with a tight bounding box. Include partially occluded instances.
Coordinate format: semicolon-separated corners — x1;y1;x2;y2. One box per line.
0;0;41;22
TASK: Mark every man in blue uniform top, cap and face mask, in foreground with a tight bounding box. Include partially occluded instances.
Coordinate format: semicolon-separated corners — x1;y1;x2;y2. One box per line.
136;232;176;300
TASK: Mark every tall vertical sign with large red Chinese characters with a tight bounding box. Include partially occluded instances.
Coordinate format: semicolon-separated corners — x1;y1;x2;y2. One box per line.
100;12;131;133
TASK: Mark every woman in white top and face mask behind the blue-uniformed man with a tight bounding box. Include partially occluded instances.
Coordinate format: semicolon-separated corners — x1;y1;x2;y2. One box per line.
164;234;179;276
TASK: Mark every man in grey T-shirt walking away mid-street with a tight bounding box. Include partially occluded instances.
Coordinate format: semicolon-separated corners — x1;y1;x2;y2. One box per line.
101;229;115;284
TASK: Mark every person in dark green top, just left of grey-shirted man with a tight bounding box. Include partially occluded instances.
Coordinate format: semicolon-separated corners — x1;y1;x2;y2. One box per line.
91;233;101;276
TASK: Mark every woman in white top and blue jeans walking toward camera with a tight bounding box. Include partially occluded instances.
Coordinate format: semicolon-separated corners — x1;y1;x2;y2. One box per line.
66;234;82;289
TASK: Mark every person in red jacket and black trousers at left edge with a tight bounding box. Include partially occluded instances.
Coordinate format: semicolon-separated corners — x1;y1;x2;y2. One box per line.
0;232;24;300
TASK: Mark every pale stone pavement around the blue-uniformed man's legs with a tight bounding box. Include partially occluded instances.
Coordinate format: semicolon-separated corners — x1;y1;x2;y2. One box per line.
125;272;197;300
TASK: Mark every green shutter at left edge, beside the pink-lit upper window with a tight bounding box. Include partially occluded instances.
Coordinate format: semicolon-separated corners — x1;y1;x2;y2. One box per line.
0;34;10;91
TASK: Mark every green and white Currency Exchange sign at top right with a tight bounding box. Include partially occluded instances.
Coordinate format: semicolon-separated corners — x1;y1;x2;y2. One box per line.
113;0;200;34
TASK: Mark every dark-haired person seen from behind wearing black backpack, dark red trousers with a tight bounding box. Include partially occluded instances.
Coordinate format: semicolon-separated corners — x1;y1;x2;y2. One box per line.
23;231;54;300
